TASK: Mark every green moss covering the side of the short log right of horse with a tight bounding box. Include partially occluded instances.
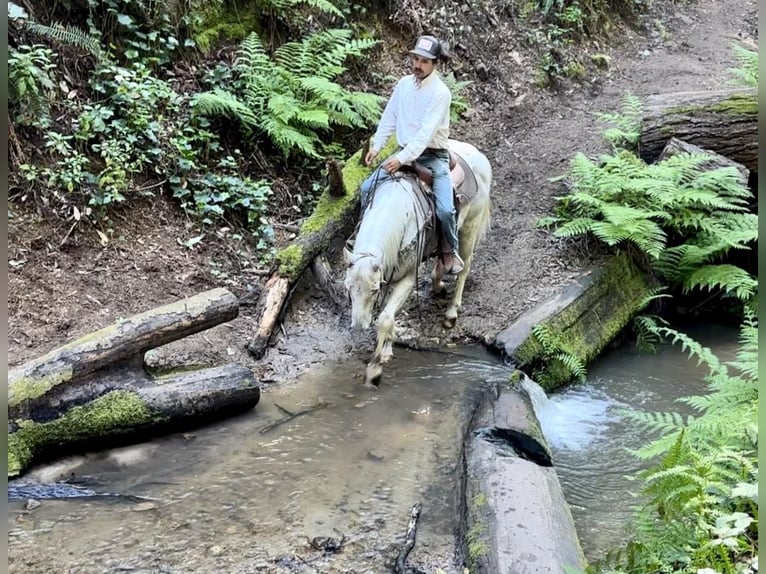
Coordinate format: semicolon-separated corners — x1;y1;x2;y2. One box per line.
514;253;649;391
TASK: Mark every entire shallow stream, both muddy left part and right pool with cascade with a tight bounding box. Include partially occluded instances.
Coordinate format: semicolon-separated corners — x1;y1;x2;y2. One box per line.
8;328;737;574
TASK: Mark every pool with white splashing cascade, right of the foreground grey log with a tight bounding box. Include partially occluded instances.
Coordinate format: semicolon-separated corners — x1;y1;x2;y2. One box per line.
530;325;738;561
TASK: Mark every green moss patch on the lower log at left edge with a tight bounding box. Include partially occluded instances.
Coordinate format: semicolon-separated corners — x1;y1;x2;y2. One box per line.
8;390;163;477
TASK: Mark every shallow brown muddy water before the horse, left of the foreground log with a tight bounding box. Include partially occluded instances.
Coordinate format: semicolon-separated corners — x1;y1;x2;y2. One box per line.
8;350;509;574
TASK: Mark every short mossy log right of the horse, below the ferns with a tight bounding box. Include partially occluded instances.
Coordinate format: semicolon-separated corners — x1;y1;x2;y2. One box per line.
494;253;651;390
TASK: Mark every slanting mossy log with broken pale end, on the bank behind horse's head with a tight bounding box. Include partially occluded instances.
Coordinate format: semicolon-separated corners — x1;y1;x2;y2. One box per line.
248;137;396;359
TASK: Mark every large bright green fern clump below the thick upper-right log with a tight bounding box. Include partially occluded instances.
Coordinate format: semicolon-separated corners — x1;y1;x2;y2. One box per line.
539;146;758;312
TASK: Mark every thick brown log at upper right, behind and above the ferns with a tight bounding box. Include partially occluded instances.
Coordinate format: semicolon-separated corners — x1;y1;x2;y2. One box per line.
639;88;758;173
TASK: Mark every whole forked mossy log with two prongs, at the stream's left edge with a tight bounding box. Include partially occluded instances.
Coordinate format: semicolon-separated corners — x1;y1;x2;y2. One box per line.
8;289;260;482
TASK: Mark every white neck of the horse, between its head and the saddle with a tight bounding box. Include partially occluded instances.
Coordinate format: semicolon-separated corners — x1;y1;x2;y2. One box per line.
354;178;424;277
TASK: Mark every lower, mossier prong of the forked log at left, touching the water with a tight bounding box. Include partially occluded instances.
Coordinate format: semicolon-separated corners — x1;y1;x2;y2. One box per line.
8;364;260;477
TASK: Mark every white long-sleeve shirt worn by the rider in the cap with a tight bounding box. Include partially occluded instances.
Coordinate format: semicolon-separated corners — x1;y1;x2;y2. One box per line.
372;70;452;163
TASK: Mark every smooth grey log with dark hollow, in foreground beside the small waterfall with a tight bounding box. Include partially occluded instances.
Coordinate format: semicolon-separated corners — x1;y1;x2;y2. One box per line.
460;385;585;574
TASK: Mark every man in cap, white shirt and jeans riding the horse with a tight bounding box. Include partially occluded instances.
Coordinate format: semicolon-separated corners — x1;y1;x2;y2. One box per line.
360;36;464;275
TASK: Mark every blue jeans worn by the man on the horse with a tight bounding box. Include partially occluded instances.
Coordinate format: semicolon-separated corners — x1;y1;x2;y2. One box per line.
359;150;458;253
